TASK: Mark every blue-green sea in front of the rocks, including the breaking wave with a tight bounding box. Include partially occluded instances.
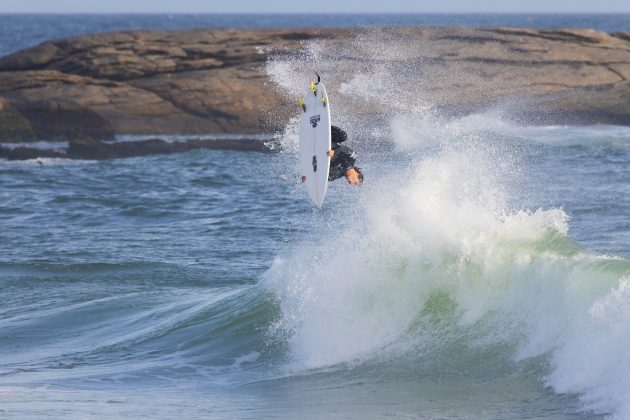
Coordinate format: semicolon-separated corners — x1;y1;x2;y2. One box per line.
0;14;630;419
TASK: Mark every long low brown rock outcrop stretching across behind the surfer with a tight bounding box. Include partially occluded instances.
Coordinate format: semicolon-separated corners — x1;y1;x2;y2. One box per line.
0;28;630;159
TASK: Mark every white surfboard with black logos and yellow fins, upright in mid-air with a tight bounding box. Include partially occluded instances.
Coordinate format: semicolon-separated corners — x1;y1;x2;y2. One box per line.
299;82;331;207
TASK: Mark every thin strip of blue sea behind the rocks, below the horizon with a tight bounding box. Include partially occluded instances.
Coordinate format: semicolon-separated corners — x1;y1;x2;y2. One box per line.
0;13;630;55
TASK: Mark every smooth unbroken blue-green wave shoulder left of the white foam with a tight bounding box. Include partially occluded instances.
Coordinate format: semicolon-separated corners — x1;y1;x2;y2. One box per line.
0;283;277;387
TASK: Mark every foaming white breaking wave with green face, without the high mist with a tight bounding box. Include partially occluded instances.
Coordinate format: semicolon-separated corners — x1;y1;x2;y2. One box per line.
266;124;630;413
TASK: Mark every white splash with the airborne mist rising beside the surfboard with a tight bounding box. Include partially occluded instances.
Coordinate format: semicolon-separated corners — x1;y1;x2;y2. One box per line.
265;33;630;418
